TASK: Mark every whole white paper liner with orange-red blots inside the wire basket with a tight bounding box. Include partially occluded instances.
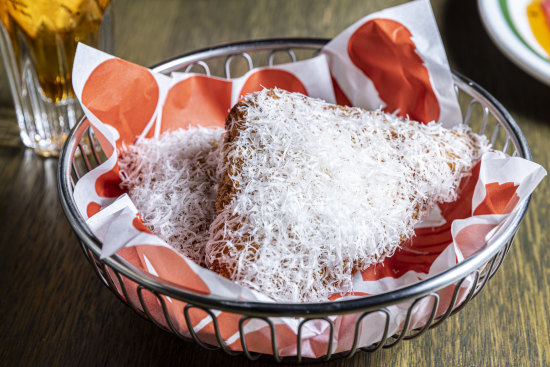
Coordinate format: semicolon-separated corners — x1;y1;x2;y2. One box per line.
73;1;546;358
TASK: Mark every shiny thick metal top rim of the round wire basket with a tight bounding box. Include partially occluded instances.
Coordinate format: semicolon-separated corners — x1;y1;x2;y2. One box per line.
57;38;531;317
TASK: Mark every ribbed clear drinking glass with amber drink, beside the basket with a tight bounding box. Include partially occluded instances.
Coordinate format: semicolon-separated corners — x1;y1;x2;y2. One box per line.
0;0;113;156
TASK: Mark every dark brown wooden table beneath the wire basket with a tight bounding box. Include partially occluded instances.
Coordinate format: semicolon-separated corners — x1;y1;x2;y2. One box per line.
0;0;550;366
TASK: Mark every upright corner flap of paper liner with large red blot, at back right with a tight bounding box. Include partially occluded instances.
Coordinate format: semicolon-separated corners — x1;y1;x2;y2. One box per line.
323;1;462;127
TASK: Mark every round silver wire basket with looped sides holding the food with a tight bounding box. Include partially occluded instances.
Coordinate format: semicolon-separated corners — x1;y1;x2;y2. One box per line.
58;38;531;362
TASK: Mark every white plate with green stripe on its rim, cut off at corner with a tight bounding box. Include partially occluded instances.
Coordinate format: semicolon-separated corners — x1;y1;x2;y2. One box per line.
477;0;550;85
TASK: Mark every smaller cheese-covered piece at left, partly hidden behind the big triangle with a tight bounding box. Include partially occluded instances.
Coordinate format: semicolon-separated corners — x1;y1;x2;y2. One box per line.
118;128;224;265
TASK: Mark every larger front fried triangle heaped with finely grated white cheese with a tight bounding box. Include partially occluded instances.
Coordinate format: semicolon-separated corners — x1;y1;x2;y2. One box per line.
206;89;488;302
